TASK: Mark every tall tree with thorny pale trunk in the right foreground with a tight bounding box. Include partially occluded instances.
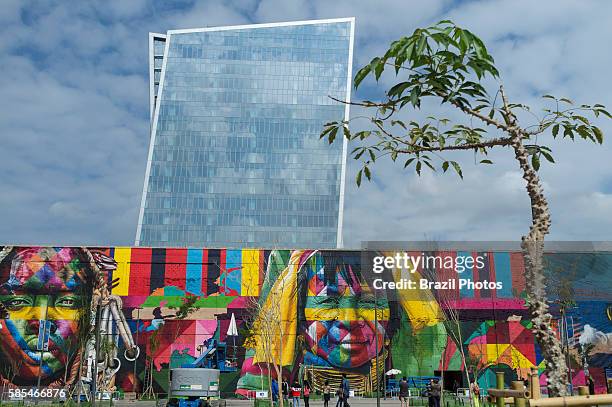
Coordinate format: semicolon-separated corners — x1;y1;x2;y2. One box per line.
321;20;612;395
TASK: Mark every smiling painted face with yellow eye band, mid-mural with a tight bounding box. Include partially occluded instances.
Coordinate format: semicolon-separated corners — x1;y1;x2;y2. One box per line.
300;252;390;369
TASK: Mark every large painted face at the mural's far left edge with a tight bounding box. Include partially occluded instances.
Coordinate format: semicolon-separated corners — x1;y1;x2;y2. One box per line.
0;247;91;384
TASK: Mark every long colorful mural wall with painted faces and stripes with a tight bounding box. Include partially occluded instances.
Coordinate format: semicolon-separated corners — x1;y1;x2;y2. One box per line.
0;247;612;395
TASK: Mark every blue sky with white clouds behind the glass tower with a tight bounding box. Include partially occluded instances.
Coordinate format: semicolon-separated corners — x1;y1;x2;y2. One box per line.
0;0;612;247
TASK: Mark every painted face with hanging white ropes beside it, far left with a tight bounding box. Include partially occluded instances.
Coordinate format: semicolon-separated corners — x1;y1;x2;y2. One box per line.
0;247;138;389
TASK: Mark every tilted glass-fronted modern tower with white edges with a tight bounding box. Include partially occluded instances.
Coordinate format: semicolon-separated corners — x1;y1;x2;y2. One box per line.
136;18;355;248
